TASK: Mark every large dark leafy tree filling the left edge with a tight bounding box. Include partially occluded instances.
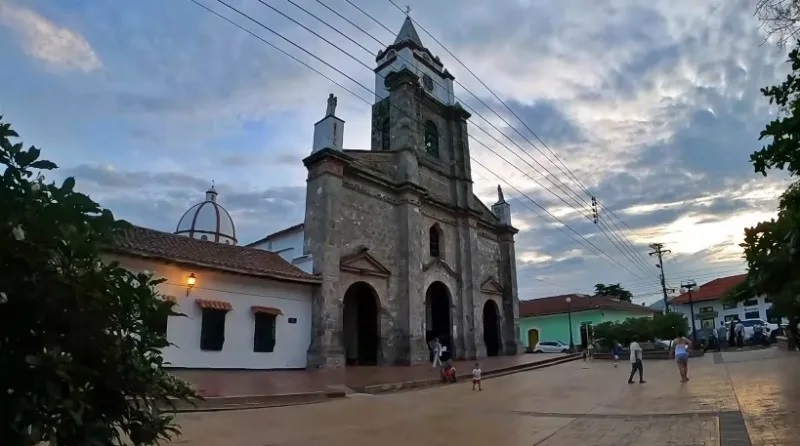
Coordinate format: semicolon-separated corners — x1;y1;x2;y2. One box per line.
0;118;196;446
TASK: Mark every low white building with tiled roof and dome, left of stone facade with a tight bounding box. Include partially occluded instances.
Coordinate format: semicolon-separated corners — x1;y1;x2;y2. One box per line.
107;188;320;369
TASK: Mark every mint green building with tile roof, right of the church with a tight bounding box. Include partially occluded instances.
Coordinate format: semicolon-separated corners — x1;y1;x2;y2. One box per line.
519;294;657;349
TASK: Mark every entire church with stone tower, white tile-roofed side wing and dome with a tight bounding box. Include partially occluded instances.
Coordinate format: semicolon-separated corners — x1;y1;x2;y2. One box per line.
109;17;520;369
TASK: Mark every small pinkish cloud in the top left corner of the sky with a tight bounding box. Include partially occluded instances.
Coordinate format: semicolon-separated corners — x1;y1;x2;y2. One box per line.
0;0;103;73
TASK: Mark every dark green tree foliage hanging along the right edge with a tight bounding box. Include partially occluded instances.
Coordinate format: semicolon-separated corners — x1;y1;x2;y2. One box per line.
727;42;800;317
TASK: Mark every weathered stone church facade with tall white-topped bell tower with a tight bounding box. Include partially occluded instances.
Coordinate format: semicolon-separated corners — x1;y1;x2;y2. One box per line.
296;18;520;367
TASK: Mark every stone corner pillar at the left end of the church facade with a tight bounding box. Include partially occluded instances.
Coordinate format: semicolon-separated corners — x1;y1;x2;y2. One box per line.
303;149;349;367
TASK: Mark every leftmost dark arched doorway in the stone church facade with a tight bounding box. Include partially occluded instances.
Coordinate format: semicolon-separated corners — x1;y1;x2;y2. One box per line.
342;282;380;365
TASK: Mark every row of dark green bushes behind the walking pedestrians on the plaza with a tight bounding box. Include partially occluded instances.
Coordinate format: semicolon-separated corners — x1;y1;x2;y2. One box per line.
594;313;689;349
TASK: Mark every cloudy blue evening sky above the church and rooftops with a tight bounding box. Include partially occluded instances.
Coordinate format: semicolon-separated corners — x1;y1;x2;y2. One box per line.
0;0;789;303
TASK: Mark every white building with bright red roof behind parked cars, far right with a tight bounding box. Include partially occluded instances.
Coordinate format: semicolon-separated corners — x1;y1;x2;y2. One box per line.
670;274;779;330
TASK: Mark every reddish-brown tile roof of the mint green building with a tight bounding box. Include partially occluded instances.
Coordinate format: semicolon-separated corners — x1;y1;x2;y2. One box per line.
519;294;658;317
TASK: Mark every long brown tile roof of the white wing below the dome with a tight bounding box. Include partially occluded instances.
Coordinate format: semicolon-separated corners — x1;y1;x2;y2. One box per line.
109;226;320;283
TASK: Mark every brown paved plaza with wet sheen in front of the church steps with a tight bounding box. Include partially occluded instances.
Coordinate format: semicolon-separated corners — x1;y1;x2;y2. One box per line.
169;348;800;446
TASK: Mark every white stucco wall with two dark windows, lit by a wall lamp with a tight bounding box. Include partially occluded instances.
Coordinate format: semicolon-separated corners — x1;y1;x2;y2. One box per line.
110;256;314;369
